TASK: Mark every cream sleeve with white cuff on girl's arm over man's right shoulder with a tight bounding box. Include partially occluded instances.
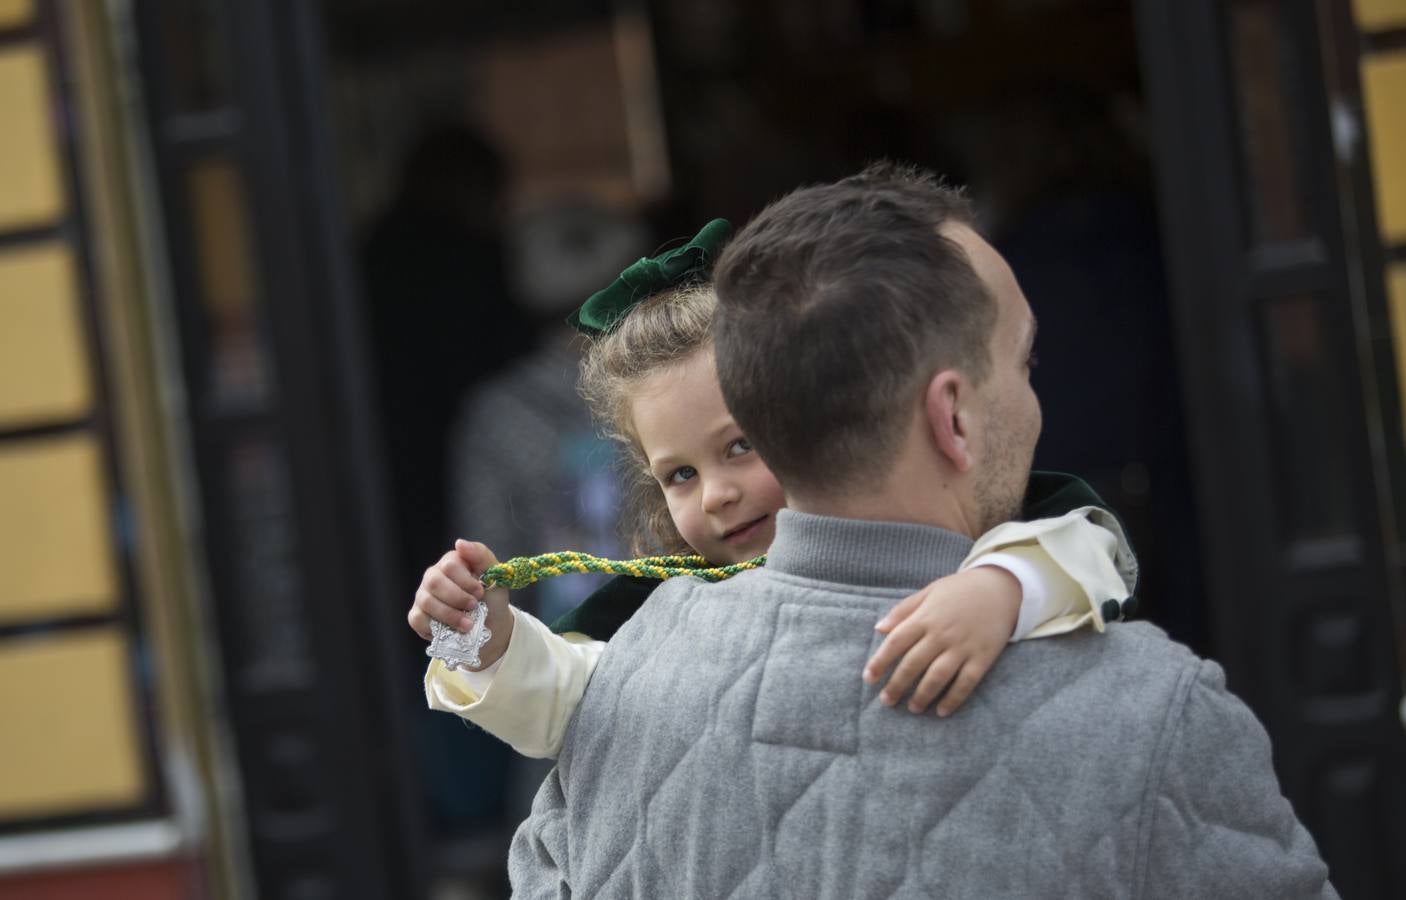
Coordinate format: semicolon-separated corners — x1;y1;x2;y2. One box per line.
962;506;1137;638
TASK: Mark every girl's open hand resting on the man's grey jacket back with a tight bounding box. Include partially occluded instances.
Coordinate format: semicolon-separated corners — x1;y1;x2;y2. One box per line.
865;565;1021;716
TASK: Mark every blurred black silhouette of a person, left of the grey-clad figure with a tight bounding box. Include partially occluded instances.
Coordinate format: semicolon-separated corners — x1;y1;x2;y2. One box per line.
361;124;534;613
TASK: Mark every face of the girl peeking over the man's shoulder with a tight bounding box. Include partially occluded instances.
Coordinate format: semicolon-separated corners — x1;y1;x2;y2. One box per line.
630;346;786;564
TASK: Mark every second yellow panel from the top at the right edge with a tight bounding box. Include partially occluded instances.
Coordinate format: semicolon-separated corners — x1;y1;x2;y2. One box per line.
1362;52;1406;243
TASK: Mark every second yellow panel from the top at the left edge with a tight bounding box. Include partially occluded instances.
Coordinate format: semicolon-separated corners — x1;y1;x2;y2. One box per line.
0;45;63;231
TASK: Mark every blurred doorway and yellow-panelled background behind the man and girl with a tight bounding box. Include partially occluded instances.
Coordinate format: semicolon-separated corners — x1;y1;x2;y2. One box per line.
0;0;1406;900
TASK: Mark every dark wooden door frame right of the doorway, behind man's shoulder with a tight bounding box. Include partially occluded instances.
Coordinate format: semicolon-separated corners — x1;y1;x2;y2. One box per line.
1136;0;1406;899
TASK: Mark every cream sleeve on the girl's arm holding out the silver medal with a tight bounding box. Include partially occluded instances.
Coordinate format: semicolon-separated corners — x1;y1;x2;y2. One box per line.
425;609;605;758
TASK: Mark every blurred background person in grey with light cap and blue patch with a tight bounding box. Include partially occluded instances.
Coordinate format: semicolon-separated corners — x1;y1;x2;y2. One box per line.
449;197;652;630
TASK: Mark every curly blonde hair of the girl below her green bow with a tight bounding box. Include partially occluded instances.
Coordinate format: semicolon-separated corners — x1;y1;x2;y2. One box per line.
578;283;717;555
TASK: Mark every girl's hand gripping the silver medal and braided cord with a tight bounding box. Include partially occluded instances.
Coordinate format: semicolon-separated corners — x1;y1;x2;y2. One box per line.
406;540;513;668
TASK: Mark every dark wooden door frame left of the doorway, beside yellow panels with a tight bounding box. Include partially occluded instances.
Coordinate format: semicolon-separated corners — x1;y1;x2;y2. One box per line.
129;0;426;899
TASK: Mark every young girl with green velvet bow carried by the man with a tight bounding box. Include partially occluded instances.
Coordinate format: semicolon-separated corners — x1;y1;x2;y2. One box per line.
408;219;1136;757
